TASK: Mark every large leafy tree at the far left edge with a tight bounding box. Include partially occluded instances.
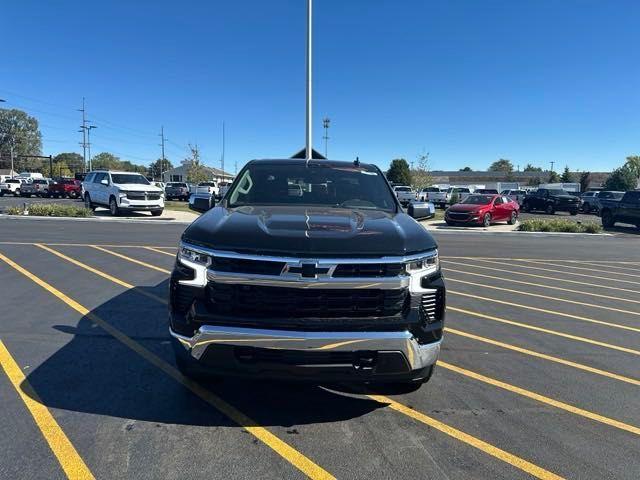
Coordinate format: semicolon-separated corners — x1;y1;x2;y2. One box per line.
0;108;42;171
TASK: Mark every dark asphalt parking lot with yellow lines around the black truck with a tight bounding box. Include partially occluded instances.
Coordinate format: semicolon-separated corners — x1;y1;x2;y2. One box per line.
0;218;640;479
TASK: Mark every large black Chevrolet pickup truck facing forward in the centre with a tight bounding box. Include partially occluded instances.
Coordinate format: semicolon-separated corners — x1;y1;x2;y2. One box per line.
169;159;445;390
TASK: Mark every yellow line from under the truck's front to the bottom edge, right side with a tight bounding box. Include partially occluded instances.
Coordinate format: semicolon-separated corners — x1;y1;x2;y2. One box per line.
367;395;562;480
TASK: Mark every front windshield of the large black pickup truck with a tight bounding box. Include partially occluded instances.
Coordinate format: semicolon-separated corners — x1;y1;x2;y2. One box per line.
229;162;397;212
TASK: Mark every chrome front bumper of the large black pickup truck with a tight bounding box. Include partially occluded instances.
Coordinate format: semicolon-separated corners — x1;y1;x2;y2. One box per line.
169;325;441;371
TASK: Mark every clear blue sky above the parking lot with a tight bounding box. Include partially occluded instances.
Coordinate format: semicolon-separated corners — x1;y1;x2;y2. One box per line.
0;0;640;171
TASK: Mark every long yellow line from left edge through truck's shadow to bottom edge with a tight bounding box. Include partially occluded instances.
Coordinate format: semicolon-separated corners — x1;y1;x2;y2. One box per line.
0;253;334;479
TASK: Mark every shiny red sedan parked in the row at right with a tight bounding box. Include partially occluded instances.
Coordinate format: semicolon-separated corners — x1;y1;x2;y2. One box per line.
444;194;520;227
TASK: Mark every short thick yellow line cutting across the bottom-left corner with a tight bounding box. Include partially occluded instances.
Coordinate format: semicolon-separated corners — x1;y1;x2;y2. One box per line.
0;340;94;480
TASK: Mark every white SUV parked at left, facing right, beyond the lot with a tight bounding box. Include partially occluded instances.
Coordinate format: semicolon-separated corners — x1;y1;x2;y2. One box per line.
82;171;164;216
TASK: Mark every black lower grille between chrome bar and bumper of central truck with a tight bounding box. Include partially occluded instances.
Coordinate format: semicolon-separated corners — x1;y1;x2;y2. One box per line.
207;282;408;318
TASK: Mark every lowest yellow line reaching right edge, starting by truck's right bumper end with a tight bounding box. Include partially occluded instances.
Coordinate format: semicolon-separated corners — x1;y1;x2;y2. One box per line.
438;360;640;435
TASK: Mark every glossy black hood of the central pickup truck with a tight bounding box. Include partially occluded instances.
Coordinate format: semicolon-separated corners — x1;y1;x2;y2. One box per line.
182;206;437;257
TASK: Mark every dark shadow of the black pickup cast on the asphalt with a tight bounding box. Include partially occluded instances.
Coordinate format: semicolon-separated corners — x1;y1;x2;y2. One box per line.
23;281;384;427
